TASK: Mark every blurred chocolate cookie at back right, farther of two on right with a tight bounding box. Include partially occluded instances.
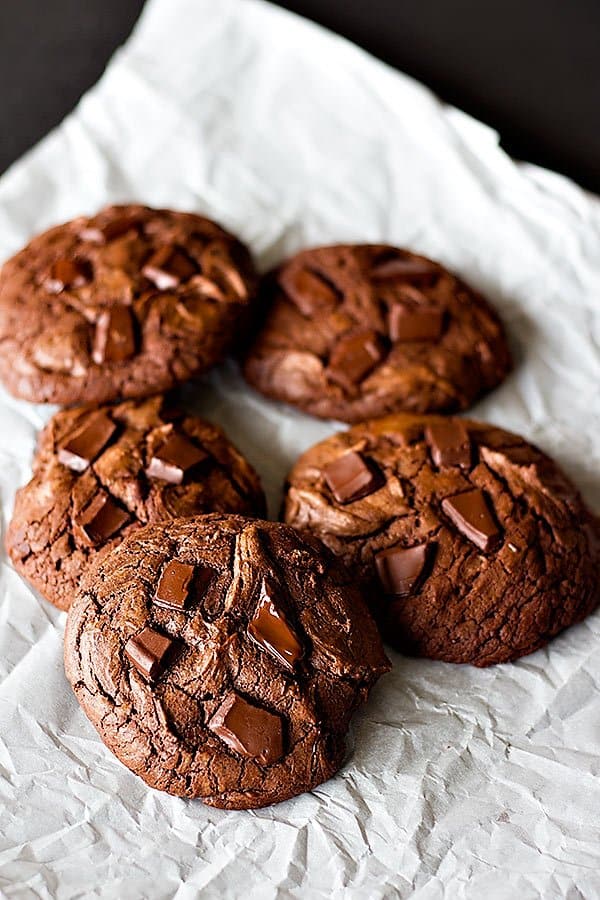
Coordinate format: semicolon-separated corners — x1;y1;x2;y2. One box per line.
244;244;511;422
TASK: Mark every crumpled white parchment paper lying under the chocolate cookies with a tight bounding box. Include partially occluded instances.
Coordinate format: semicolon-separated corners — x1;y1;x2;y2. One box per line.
0;0;600;900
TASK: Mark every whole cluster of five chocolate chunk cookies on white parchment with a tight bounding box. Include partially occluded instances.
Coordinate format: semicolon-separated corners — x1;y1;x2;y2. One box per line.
0;205;600;809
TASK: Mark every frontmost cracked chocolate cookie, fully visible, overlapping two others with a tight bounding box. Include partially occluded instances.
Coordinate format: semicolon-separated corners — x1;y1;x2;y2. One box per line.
65;514;389;809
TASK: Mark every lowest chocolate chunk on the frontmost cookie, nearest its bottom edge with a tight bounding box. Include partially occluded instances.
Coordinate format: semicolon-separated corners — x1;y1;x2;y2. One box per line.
208;691;283;766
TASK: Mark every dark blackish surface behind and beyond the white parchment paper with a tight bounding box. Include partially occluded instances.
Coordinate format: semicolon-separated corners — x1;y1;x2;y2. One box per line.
0;0;600;192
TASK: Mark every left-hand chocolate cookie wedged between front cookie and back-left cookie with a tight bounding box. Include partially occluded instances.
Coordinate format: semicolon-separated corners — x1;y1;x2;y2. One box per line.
6;396;265;609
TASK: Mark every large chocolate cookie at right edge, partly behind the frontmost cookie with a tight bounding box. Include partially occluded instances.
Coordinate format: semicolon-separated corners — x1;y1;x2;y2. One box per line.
285;415;600;666
